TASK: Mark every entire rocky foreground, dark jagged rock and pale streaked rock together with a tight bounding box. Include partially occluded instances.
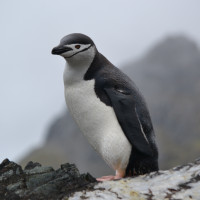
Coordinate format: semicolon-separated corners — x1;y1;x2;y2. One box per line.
0;158;200;200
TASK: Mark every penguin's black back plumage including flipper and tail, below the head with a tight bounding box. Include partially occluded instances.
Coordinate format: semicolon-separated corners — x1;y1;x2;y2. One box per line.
84;52;158;175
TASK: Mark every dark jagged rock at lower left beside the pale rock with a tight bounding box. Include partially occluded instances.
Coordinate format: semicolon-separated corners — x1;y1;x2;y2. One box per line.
0;159;96;200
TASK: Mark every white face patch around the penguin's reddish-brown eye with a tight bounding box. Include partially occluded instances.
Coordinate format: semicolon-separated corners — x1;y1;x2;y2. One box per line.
60;44;91;59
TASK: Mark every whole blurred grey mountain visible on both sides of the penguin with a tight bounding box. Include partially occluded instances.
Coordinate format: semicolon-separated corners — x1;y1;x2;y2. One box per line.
19;36;200;176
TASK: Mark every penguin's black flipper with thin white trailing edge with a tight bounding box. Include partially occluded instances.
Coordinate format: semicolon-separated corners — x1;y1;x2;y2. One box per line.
104;88;152;155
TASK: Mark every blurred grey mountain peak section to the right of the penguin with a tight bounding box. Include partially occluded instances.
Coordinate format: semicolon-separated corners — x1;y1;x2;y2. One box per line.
124;36;200;169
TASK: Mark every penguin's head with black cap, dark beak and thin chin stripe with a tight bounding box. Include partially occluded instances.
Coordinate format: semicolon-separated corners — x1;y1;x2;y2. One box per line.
52;33;97;62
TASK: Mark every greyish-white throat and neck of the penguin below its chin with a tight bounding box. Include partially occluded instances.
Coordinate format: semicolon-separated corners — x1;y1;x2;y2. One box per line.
63;47;98;86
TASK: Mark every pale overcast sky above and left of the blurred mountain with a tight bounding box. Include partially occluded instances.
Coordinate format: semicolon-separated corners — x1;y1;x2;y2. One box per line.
0;0;200;162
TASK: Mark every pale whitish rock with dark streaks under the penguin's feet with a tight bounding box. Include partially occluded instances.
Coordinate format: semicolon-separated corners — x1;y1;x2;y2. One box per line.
66;158;200;200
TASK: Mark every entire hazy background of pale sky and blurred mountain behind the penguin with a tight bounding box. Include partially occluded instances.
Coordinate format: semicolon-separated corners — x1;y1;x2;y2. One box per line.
0;0;200;175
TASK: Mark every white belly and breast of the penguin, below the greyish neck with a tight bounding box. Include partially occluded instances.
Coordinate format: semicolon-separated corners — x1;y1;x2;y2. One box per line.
65;80;131;170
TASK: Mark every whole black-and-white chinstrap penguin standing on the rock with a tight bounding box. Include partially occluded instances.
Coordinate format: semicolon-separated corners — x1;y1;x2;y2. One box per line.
52;33;158;181
